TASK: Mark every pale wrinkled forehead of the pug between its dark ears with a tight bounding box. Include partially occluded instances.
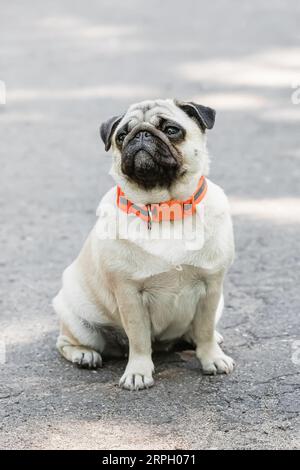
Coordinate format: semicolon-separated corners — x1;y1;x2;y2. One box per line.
120;100;180;131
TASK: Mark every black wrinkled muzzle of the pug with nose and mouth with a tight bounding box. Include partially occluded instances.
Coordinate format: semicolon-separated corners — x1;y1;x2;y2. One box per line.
121;127;181;189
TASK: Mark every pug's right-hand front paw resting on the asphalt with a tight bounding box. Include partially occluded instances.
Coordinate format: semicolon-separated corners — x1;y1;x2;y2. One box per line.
196;344;235;375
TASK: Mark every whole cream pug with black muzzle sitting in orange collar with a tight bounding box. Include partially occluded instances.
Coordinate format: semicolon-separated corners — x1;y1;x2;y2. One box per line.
53;99;234;390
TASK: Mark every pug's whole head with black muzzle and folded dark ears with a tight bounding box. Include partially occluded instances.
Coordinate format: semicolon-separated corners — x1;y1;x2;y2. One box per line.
100;100;215;190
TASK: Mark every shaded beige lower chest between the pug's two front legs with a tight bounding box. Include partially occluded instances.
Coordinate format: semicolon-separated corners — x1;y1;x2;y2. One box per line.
142;265;205;340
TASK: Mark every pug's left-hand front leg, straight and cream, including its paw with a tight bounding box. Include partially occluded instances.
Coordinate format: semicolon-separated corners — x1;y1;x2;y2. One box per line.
115;282;154;390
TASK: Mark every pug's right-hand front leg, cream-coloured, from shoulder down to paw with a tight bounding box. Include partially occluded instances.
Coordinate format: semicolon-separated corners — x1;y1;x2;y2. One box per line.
193;274;234;375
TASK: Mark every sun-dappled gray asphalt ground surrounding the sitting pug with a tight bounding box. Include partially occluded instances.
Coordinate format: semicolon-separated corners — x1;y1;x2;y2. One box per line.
0;0;300;449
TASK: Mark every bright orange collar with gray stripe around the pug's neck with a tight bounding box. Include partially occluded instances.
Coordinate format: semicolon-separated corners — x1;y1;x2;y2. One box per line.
117;176;207;229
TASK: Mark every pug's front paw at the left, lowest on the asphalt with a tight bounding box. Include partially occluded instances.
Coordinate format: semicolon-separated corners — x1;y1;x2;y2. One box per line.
119;358;154;390
